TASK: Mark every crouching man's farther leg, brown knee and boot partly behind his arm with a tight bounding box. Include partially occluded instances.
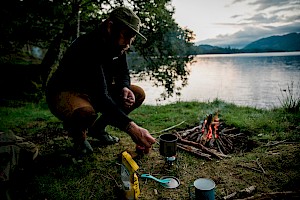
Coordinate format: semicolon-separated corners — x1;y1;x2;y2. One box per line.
89;85;145;145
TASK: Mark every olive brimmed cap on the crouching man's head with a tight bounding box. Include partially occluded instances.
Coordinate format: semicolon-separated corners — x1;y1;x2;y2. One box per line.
109;7;147;40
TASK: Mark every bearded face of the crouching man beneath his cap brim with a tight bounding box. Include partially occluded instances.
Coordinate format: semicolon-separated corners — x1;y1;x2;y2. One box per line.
114;28;136;56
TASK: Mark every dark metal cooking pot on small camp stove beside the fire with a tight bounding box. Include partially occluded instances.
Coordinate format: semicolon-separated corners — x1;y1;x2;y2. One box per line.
159;133;178;157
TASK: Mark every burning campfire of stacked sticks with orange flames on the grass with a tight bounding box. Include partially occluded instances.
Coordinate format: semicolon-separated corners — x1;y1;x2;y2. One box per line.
174;112;248;160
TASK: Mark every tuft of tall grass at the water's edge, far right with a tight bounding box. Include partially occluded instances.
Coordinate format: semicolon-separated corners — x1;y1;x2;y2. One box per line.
278;81;300;112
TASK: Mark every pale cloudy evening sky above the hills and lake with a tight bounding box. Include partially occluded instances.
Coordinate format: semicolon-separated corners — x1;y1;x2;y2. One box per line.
172;0;300;48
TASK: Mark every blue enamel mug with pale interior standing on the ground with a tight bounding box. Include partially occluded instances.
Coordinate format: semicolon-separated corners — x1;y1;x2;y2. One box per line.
189;178;216;200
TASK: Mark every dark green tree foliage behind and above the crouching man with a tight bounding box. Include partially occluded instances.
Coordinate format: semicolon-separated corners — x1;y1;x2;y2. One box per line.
0;0;194;99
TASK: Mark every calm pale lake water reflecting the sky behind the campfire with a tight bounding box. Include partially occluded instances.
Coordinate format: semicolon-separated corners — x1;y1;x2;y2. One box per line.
133;52;300;109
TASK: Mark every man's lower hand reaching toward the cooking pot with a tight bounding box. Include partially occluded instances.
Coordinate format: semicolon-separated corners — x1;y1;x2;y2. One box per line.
126;122;156;154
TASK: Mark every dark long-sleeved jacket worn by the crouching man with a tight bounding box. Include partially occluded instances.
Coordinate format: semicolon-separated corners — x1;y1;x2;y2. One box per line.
46;26;132;129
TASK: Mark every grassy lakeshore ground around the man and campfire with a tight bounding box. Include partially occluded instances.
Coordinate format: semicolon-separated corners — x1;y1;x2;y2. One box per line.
0;100;300;200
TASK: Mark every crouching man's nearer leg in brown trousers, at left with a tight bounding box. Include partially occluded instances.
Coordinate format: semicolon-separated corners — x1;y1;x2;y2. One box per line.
48;92;97;154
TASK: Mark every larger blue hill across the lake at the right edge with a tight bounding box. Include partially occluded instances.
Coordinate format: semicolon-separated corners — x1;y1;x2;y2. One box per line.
242;33;300;52
